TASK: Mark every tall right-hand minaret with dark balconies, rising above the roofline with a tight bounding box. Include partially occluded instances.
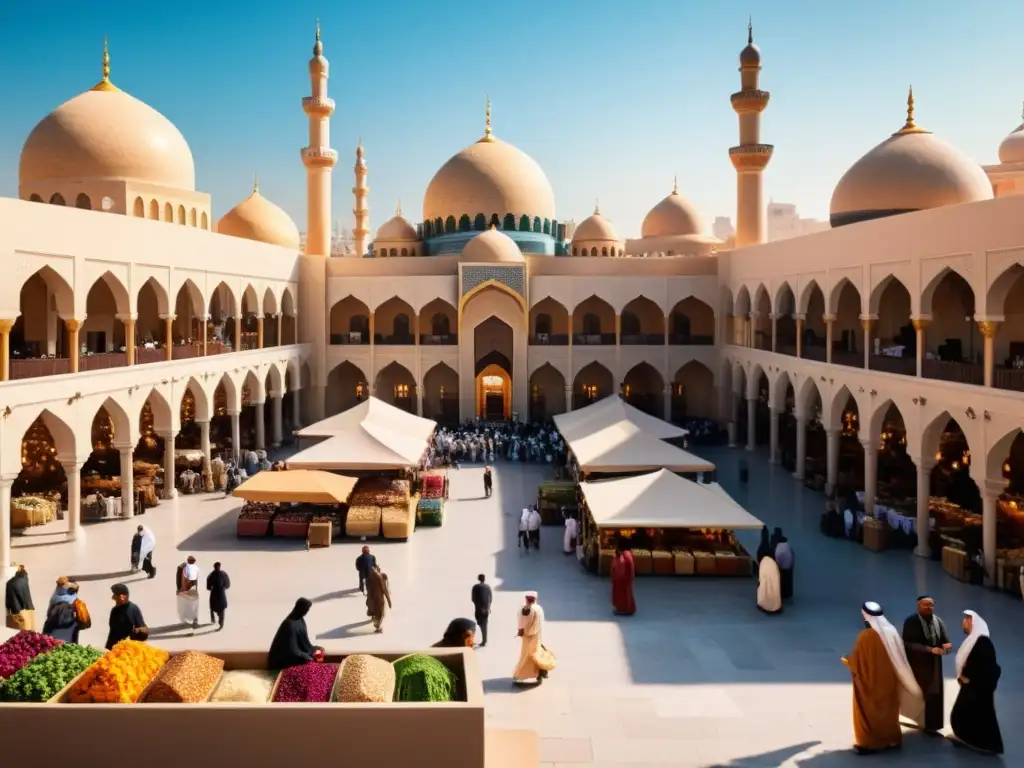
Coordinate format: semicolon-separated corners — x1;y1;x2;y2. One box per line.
729;23;774;248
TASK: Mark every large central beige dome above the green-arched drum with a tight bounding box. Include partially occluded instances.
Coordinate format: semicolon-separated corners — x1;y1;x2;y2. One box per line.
423;132;555;221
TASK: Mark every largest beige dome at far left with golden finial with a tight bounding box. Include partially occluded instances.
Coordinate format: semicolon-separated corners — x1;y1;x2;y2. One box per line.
18;50;196;191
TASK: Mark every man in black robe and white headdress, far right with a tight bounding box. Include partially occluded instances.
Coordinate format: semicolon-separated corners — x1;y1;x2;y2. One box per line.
949;610;1002;755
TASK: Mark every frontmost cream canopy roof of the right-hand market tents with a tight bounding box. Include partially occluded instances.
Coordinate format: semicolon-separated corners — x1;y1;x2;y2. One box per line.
580;469;764;530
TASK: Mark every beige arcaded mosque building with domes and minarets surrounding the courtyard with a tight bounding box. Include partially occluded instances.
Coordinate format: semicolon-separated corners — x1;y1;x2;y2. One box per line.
0;22;1024;577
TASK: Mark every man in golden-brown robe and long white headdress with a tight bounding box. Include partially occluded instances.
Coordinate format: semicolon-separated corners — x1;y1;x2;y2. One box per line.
843;602;925;753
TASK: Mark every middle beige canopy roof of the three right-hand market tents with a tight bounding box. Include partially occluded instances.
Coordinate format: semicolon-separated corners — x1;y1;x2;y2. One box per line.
566;422;715;472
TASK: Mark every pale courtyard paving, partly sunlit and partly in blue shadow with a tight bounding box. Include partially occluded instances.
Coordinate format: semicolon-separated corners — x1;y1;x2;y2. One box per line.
0;449;1024;768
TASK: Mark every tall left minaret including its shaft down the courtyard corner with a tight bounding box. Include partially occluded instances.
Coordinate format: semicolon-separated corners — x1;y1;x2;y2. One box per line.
296;22;338;424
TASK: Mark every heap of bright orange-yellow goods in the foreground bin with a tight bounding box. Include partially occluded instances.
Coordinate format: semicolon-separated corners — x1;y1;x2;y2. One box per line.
68;640;170;703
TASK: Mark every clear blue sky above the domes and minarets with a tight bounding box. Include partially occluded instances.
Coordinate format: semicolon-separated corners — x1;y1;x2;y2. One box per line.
0;0;1024;237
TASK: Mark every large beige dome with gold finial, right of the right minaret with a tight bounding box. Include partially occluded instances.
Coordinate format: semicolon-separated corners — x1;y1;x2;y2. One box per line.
829;93;992;226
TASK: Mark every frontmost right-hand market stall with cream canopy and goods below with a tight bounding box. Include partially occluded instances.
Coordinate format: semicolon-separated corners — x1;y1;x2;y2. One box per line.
578;469;764;577
